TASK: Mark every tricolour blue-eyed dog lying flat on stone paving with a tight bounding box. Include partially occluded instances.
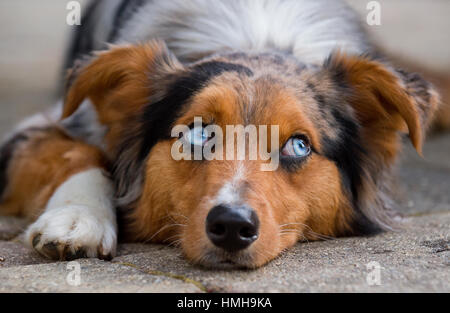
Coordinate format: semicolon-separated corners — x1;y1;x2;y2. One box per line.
0;0;439;269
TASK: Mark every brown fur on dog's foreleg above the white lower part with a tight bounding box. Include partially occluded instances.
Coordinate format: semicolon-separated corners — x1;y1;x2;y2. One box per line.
0;127;106;221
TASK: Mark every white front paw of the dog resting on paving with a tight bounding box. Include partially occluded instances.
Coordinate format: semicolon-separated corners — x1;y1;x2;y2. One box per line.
25;205;117;261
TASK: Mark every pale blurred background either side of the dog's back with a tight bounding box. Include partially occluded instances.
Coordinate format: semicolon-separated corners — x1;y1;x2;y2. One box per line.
0;0;450;136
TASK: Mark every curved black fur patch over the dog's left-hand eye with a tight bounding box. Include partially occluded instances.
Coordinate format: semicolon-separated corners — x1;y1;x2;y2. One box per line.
135;61;253;160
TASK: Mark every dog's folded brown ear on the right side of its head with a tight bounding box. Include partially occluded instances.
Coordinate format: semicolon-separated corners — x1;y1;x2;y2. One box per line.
325;53;439;161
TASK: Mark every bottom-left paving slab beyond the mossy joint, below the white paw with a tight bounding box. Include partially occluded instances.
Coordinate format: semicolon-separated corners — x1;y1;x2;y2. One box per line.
0;259;202;293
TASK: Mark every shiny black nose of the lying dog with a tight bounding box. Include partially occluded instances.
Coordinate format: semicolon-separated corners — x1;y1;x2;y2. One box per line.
206;205;259;252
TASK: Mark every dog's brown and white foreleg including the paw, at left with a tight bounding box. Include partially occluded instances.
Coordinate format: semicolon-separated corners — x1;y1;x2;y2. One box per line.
0;127;117;260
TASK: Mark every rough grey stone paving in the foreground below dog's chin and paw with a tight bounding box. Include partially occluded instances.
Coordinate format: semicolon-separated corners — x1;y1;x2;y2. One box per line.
0;213;450;292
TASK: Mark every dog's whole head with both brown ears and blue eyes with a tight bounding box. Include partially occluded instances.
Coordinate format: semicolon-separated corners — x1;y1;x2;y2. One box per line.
64;43;437;268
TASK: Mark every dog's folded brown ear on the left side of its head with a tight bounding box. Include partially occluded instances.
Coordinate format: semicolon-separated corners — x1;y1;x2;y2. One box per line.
62;41;182;124
